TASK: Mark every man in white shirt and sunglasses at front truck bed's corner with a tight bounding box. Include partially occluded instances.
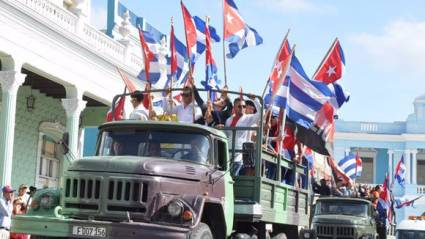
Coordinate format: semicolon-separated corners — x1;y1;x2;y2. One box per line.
226;97;261;176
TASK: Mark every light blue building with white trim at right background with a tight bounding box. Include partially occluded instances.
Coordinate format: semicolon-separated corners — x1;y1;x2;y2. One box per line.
334;95;425;221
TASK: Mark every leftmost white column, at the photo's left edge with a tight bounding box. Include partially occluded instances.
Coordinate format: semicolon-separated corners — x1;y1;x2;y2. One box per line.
0;71;26;186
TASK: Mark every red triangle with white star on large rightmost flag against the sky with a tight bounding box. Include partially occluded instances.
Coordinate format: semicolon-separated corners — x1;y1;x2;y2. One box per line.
312;38;345;84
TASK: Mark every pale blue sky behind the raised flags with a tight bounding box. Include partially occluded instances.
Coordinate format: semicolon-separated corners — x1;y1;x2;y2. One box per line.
91;0;425;122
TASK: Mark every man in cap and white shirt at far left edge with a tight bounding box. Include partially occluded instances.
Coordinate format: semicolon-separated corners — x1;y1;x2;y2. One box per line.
0;185;15;239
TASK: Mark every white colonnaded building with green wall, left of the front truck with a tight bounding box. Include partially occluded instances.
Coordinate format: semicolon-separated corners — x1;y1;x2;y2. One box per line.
0;0;152;188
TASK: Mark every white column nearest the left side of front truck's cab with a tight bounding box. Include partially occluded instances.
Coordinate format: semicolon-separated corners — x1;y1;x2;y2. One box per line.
61;96;87;172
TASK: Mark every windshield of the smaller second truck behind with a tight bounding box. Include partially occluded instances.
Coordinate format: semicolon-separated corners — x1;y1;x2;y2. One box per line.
314;201;369;217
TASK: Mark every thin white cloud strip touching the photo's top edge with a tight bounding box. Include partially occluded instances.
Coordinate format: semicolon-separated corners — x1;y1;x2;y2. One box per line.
257;0;335;13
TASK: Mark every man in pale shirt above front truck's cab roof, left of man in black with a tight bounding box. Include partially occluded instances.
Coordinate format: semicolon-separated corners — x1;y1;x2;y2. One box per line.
164;86;202;123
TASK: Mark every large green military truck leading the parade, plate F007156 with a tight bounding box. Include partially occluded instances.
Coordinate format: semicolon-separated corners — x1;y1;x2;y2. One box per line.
11;92;309;239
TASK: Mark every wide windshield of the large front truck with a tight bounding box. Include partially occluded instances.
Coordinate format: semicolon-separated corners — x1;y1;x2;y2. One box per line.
97;129;210;163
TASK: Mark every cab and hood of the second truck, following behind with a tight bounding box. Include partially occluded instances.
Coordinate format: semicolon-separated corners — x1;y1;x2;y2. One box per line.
302;197;378;239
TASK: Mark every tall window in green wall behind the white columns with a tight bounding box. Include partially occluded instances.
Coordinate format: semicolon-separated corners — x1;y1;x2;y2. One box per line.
36;133;60;187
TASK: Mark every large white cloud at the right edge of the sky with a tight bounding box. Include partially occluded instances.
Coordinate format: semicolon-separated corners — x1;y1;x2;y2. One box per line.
351;20;425;77
